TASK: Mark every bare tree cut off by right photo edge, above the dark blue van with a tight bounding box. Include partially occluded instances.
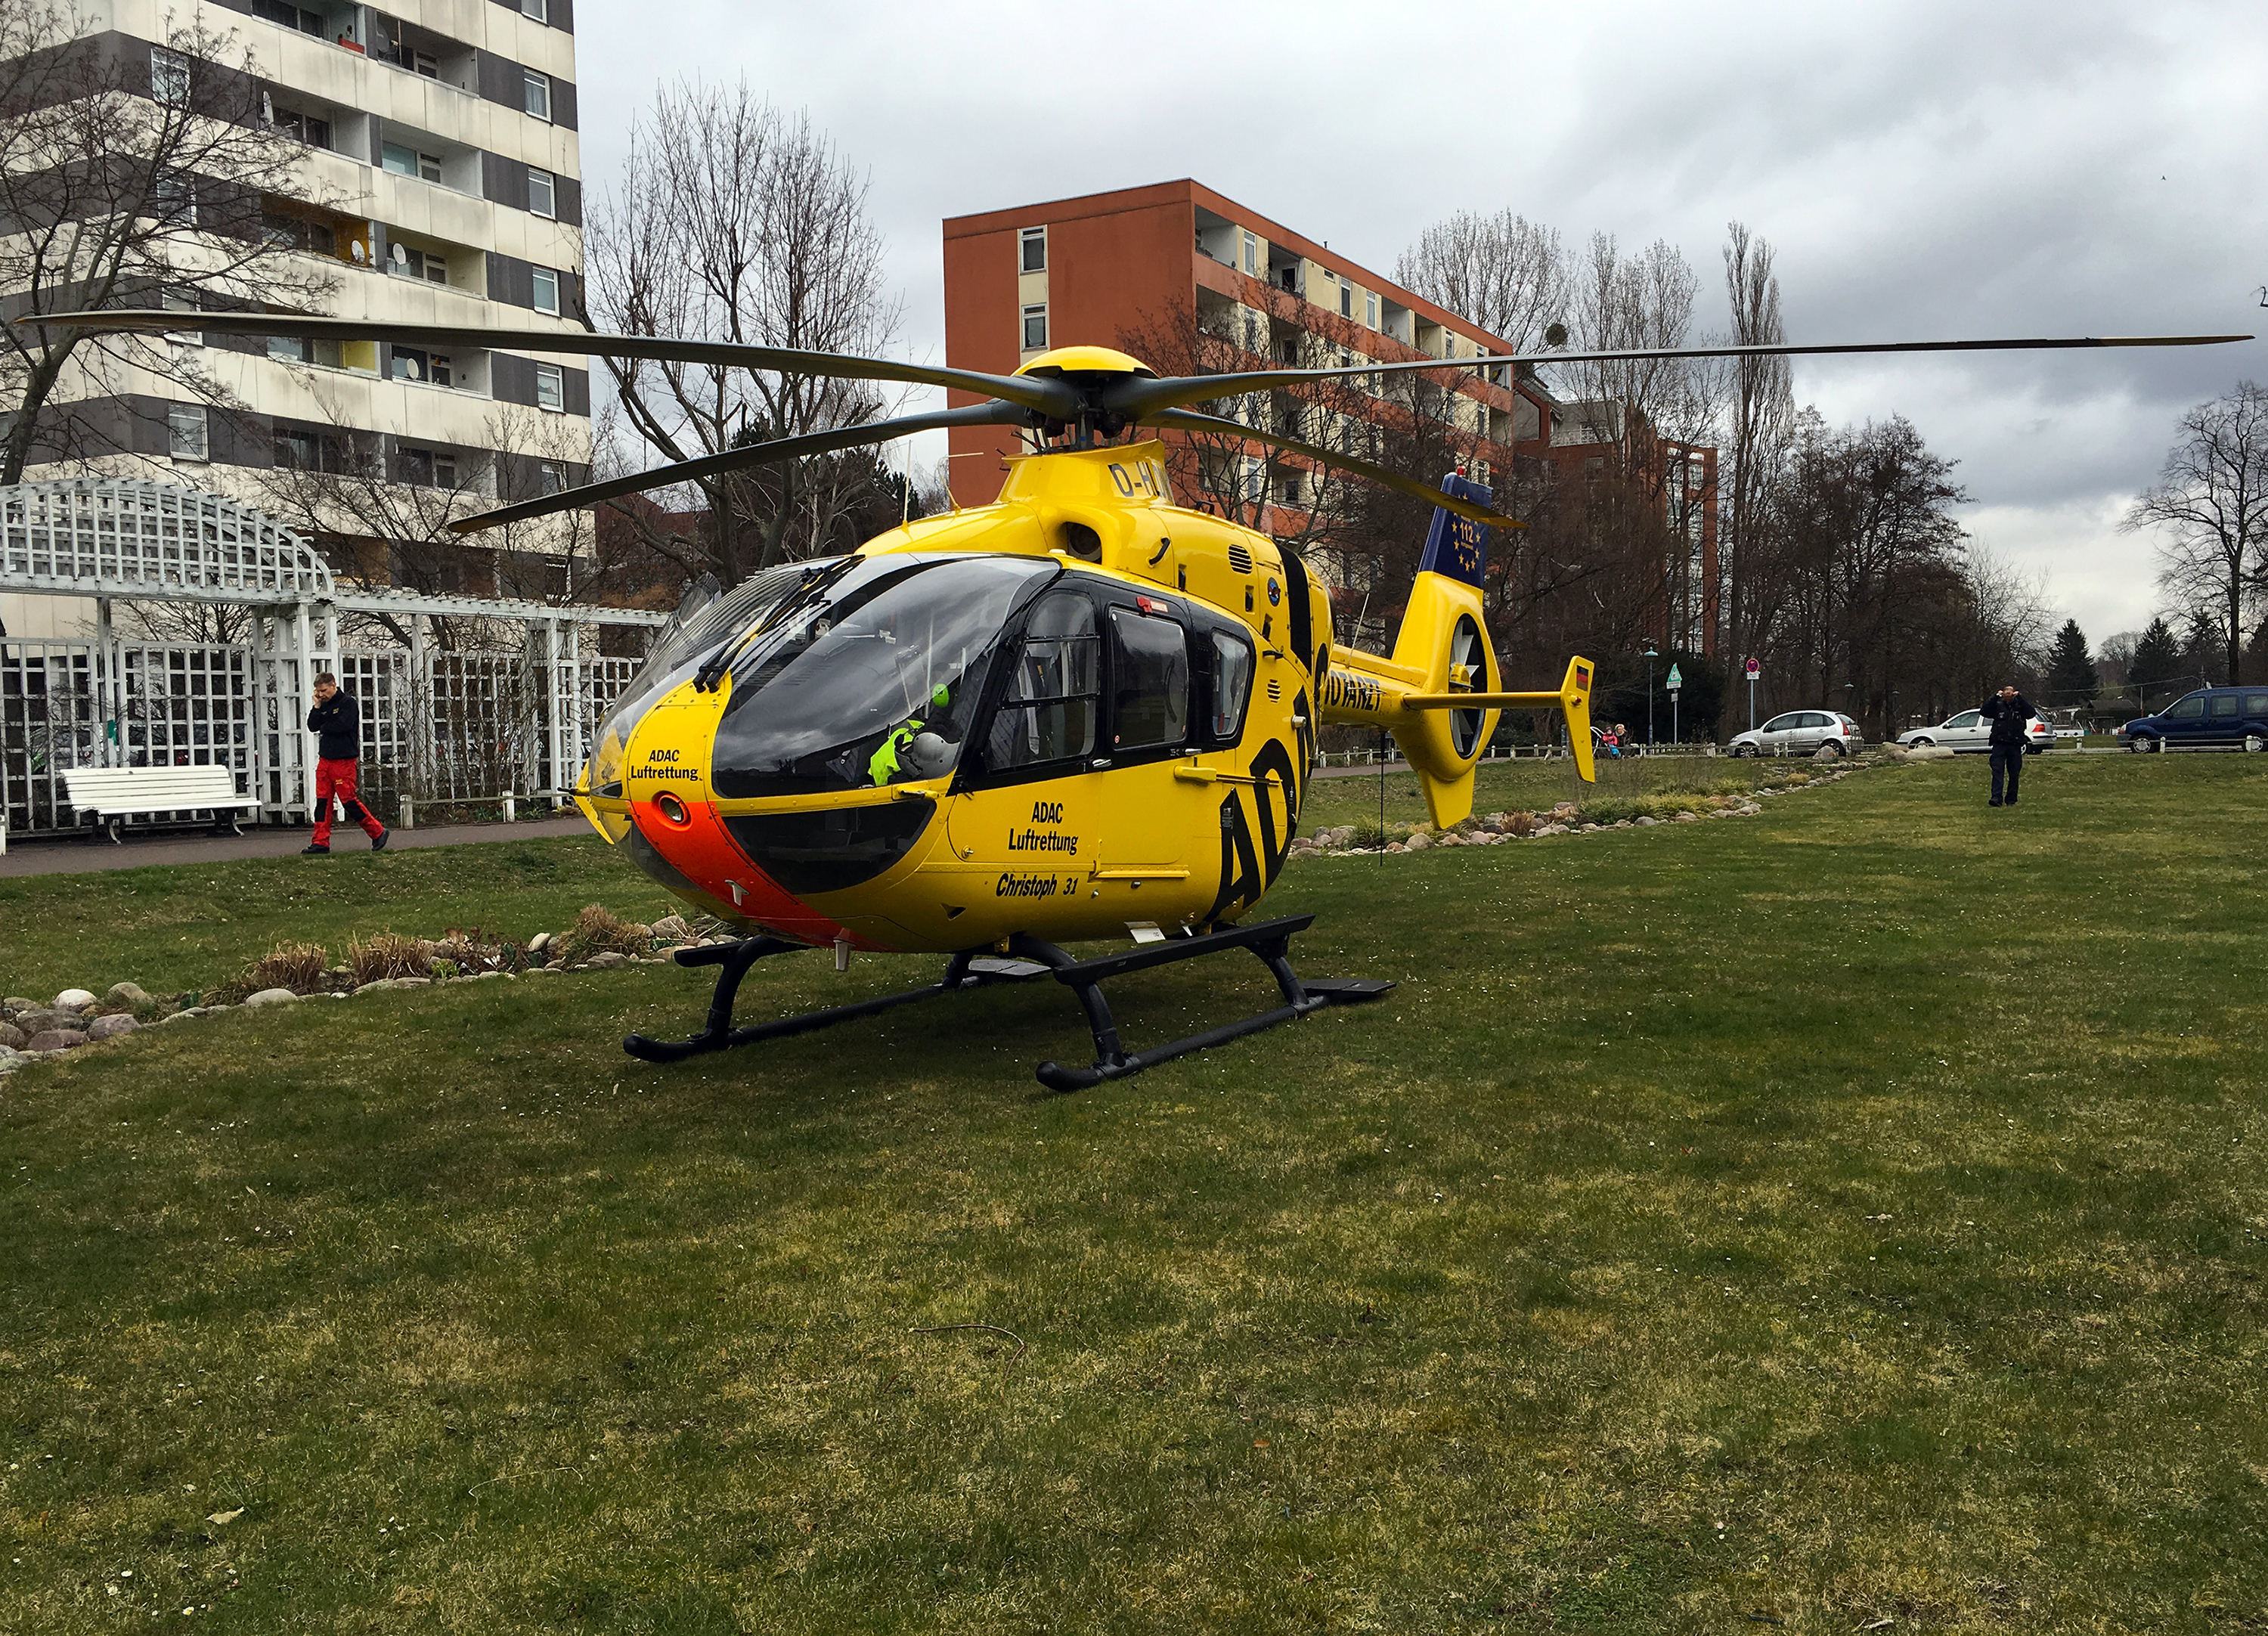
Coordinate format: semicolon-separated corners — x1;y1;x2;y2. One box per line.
2121;381;2268;685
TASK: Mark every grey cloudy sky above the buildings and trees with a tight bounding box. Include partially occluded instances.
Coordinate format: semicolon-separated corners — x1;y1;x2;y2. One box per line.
578;0;2268;637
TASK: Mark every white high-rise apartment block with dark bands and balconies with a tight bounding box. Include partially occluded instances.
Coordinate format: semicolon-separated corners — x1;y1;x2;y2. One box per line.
7;0;590;635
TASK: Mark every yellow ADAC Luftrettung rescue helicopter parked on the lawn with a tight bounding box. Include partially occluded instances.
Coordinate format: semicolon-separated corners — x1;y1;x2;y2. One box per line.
36;311;2234;1089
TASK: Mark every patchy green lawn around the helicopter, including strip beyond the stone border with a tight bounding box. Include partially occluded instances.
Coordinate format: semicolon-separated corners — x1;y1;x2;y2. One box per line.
0;755;2268;1636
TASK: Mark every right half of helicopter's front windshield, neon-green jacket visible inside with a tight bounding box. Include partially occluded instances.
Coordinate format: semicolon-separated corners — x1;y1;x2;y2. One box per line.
710;553;1061;796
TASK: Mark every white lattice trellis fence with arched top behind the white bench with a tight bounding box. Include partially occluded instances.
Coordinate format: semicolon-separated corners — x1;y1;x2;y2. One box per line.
0;479;667;838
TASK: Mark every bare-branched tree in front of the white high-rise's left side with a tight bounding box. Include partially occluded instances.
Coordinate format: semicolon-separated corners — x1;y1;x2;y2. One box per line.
0;0;333;483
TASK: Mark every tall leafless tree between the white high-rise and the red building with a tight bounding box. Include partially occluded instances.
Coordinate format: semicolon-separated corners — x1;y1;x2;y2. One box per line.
585;82;900;583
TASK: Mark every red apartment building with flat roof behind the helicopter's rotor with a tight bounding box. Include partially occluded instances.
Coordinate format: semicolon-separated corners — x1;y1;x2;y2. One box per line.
943;179;1717;651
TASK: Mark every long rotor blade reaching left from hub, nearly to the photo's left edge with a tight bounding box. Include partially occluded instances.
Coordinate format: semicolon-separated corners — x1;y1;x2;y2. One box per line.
16;308;1086;420
